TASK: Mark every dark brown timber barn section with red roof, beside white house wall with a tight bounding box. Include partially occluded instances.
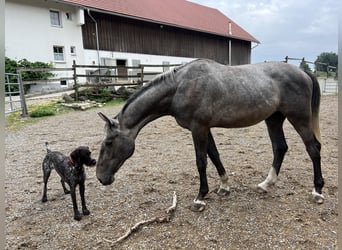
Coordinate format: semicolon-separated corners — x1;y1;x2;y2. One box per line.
65;0;259;66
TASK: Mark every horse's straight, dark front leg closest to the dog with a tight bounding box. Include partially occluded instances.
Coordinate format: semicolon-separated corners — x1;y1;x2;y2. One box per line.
191;130;209;212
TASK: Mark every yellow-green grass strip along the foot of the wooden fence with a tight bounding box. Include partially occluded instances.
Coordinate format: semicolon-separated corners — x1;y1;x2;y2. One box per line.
6;100;125;130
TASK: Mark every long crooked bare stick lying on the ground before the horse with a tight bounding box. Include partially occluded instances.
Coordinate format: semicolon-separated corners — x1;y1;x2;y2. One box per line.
110;192;177;244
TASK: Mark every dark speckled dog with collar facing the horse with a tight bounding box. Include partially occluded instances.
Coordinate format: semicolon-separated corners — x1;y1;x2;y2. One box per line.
42;142;96;221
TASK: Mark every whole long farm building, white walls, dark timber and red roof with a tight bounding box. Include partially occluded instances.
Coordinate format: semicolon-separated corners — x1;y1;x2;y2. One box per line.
5;0;259;89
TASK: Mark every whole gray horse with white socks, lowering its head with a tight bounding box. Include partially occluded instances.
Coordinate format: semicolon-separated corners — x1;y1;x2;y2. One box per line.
96;59;324;211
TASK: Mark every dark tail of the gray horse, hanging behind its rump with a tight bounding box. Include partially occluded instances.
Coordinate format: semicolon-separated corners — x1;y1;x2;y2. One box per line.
306;72;322;147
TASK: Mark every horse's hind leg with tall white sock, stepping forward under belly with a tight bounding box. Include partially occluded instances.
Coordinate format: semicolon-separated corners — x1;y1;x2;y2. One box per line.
257;112;288;193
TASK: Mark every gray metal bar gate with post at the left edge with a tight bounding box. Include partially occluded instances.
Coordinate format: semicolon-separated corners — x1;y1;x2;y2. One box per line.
4;73;27;117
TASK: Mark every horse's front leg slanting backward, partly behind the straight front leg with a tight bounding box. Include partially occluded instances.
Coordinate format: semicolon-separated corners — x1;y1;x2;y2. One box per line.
207;131;230;196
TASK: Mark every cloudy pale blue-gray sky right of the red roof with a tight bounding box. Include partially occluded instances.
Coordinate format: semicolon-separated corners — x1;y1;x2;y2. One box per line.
191;0;340;64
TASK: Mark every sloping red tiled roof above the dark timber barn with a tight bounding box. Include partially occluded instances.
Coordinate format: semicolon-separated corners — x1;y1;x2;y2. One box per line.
61;0;260;43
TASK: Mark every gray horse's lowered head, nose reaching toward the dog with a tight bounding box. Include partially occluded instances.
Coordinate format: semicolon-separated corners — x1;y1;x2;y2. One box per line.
96;112;135;185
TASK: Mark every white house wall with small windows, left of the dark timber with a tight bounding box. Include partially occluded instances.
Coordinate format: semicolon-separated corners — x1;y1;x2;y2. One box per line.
5;0;84;67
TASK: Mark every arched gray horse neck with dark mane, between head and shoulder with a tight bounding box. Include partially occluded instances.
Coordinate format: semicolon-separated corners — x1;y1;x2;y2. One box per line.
118;74;177;139
